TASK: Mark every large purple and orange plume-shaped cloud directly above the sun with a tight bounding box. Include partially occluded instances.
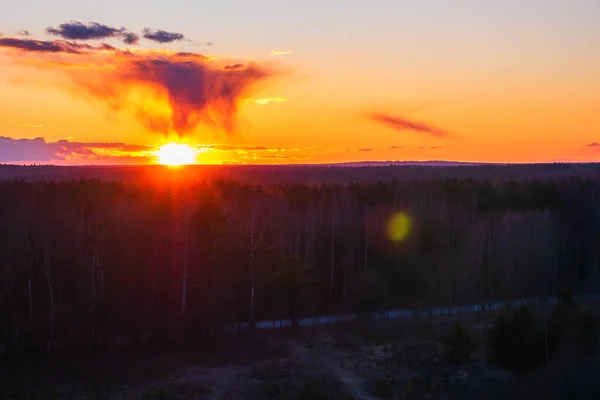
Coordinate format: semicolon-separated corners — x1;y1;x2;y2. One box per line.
65;54;273;135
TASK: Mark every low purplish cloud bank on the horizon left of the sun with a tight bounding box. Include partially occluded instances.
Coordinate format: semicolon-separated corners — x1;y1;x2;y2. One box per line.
0;136;155;162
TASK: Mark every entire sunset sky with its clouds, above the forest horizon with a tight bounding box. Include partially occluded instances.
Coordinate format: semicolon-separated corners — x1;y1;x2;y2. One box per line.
0;0;600;164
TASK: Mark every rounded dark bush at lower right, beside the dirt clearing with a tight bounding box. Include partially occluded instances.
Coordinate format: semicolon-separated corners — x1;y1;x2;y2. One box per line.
488;307;545;372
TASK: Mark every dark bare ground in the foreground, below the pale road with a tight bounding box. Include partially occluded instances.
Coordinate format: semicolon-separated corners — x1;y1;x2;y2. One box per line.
0;320;600;400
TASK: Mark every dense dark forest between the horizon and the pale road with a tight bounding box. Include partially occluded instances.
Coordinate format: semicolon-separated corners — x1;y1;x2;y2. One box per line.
0;173;600;357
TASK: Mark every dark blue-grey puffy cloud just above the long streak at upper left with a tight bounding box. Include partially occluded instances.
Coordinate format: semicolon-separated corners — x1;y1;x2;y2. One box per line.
46;21;139;44
